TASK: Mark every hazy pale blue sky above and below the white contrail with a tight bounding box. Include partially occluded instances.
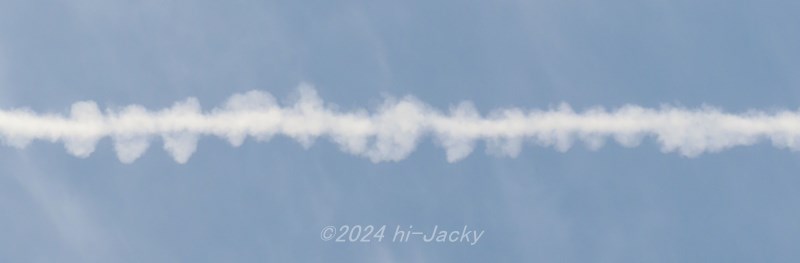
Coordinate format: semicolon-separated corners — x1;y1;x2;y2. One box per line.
0;0;800;262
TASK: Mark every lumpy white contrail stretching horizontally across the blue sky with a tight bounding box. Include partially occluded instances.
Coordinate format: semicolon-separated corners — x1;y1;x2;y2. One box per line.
0;84;800;163
